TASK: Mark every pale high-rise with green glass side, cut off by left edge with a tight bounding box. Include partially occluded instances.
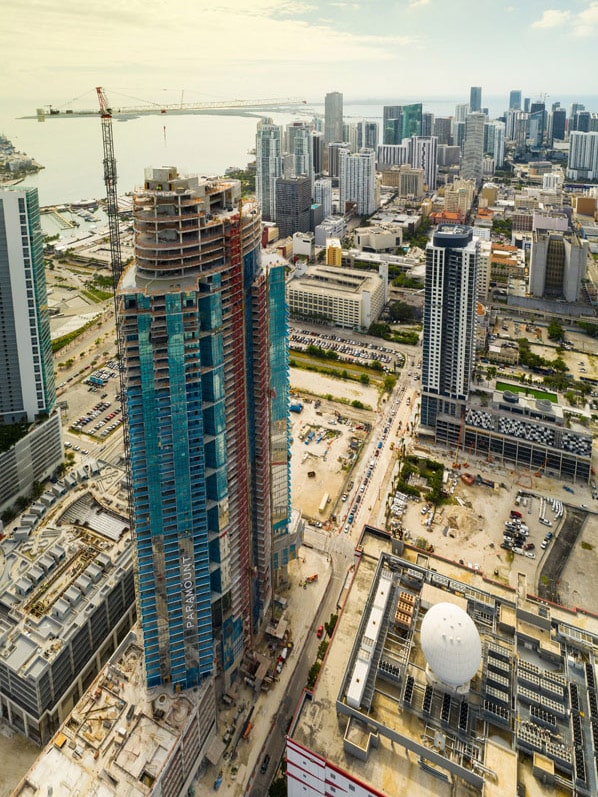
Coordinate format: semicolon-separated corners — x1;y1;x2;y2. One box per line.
0;187;63;511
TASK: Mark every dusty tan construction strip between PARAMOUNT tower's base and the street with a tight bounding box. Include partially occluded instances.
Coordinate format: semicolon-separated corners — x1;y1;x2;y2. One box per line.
199;547;332;797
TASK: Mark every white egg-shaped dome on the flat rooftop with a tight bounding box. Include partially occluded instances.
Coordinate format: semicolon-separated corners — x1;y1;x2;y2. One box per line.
420;603;482;686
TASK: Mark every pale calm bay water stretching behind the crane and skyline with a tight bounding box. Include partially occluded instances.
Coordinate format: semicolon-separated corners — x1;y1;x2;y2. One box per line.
1;95;598;206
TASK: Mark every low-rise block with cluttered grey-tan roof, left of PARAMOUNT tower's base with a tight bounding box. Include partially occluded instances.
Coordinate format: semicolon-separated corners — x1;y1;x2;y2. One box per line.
0;492;135;744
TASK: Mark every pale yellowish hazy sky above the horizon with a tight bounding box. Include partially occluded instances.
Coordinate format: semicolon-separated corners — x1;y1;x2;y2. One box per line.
0;0;598;118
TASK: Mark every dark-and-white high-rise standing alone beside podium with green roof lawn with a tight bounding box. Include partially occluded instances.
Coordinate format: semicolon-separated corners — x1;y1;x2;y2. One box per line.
420;225;478;430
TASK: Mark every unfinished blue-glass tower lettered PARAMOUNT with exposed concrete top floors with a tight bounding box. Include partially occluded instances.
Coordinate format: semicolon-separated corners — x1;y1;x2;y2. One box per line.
116;167;295;688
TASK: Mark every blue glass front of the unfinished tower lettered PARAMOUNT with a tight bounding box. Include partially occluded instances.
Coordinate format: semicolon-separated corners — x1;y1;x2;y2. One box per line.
123;291;216;687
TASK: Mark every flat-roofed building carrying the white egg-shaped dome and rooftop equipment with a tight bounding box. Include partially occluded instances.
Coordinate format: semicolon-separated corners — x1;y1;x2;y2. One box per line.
287;527;598;797
